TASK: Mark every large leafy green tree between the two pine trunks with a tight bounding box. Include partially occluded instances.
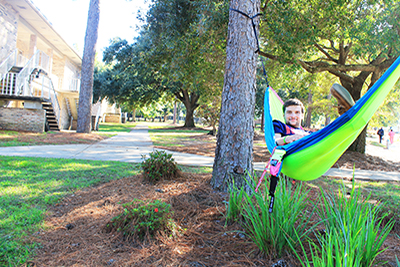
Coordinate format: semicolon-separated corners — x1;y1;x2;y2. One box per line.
92;0;226;127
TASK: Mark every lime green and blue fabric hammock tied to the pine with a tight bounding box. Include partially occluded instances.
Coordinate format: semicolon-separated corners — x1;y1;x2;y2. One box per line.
264;57;400;181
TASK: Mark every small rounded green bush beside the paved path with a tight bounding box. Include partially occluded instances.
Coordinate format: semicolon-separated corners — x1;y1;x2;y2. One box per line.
141;151;180;184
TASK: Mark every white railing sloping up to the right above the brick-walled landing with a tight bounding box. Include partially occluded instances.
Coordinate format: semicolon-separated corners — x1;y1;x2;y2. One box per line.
15;50;50;96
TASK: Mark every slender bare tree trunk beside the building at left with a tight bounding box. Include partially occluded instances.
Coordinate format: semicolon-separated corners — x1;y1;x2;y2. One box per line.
76;0;100;133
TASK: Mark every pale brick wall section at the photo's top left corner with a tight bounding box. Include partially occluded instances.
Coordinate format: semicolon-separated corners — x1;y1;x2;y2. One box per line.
0;0;19;63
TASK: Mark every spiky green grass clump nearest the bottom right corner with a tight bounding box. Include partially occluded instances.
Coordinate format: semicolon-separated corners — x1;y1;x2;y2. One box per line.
296;179;394;267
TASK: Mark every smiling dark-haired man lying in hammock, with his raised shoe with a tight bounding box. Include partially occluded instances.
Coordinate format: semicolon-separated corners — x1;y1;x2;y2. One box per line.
273;83;355;146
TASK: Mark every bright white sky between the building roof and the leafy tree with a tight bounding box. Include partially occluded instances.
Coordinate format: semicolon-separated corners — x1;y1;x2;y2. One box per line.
31;0;148;58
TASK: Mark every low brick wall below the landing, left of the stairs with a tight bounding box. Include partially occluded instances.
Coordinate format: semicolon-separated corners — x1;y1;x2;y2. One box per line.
0;107;46;133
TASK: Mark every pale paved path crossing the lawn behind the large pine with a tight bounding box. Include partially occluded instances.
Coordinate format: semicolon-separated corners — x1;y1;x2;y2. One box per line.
0;125;400;181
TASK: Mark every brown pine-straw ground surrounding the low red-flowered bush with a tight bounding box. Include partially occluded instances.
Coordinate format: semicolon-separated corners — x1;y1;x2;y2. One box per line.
30;174;400;267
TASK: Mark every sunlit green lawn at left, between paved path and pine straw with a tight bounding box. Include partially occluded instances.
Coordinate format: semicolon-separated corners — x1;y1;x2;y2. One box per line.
0;156;139;266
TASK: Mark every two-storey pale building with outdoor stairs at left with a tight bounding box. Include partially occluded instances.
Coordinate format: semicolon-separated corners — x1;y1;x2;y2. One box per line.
0;0;121;132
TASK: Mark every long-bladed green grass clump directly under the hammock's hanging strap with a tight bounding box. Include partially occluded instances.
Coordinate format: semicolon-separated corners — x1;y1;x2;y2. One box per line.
243;179;313;257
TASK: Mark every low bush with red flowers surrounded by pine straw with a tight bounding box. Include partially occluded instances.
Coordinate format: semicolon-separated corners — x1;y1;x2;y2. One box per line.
106;199;176;241
